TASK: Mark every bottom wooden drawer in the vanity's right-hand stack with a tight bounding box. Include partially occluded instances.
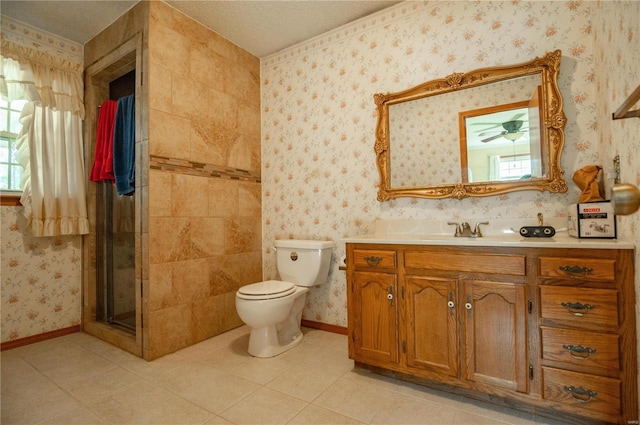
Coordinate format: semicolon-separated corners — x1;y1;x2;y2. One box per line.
542;367;620;416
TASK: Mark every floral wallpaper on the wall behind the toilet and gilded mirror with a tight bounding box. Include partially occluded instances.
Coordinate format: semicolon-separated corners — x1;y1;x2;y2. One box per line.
261;1;640;326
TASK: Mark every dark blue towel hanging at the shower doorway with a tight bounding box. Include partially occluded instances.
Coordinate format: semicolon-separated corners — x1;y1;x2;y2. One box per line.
113;95;136;195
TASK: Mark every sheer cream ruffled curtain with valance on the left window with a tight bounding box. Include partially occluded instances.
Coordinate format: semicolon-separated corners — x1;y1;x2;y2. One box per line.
0;40;89;236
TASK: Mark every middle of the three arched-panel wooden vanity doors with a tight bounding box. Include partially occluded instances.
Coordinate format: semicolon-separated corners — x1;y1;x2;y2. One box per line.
404;276;458;376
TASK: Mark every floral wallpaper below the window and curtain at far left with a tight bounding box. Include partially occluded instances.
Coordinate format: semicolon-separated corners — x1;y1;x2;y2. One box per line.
0;207;82;342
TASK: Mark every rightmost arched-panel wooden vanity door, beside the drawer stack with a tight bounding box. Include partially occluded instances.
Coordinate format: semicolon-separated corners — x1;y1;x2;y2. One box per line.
463;280;528;392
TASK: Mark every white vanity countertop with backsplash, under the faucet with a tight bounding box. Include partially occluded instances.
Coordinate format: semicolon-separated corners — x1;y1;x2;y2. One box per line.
342;220;635;249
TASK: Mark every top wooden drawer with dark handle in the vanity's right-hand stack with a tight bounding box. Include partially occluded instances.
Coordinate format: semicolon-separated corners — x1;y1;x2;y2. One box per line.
540;257;616;281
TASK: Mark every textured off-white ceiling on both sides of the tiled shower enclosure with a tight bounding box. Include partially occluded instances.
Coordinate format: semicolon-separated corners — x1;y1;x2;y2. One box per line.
0;0;399;58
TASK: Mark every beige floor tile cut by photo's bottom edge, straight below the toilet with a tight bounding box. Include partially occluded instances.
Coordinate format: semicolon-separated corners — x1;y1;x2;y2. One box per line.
220;387;307;425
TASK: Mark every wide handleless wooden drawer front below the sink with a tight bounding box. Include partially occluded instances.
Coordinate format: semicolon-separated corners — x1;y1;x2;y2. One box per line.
404;251;525;276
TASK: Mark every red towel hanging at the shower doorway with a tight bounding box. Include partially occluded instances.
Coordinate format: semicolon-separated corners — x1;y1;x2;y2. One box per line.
89;100;118;182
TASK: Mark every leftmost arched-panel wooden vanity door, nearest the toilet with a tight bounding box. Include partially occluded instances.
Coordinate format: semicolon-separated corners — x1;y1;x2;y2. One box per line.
349;272;398;364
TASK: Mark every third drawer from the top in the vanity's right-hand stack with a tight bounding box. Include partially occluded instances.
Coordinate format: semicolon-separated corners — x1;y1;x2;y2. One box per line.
541;327;620;370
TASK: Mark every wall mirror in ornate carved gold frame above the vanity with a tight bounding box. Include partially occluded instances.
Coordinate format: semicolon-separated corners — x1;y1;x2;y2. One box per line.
374;50;567;201
